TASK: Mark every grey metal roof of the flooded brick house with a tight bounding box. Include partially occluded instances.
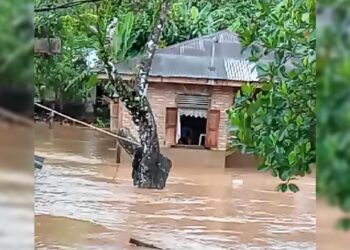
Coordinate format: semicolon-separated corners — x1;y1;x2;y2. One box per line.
117;30;272;81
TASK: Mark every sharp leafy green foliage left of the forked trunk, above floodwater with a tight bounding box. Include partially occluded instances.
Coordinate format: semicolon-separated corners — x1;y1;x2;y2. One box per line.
34;0;101;103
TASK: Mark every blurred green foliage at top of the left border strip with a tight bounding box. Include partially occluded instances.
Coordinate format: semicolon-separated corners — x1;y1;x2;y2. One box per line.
0;0;33;85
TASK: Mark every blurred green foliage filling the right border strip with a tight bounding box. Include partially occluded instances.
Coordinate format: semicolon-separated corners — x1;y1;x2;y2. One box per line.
317;3;350;225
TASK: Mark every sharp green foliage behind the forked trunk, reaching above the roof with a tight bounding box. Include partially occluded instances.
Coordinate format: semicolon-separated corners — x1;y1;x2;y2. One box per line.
34;0;235;103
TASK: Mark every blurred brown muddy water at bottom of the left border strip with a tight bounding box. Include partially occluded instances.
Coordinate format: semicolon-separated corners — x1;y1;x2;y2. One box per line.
0;125;34;250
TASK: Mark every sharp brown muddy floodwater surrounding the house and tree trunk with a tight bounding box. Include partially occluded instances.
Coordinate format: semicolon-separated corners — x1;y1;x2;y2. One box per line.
35;126;316;250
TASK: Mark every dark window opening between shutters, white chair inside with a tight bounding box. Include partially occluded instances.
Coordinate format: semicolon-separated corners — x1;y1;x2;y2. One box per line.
178;115;207;146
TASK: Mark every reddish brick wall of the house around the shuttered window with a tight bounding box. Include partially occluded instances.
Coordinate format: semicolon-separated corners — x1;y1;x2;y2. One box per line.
119;82;235;150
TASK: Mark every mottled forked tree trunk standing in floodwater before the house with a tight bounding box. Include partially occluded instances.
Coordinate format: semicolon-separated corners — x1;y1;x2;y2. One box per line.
100;0;171;189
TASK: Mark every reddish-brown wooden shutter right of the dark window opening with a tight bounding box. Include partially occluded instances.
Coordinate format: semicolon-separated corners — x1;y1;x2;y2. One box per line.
205;110;220;148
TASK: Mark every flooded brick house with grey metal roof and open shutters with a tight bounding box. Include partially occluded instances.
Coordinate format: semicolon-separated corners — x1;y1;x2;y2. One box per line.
100;30;266;167
